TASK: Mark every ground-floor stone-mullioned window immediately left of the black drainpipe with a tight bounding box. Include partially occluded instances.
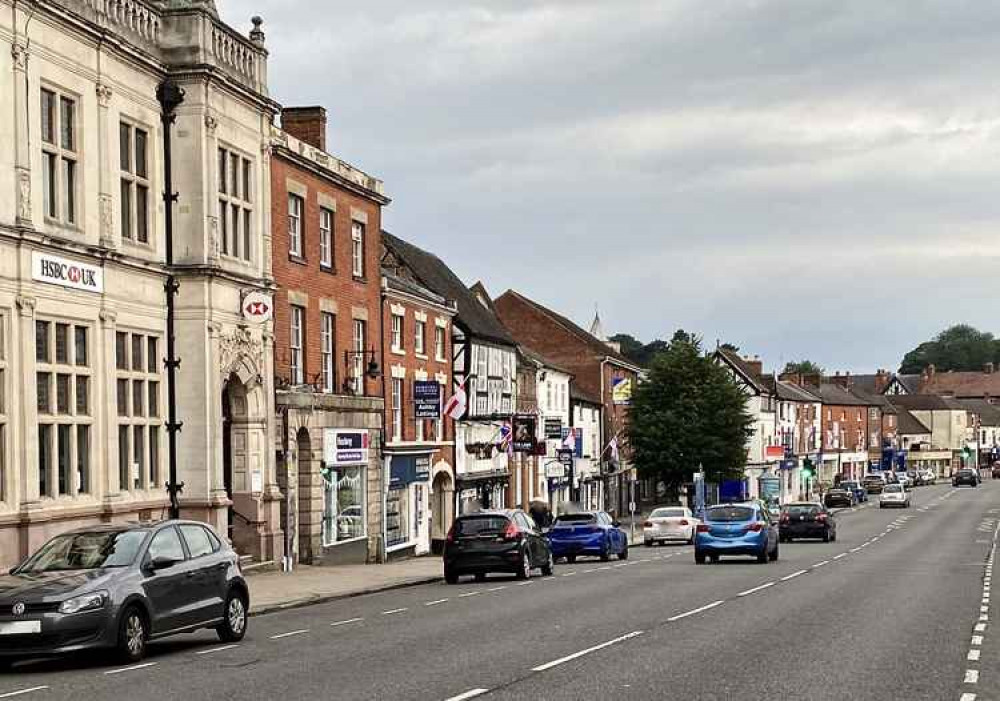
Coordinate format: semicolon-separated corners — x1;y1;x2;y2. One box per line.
115;331;163;491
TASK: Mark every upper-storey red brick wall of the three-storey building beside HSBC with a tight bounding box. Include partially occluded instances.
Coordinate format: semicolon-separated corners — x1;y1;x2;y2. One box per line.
271;154;382;395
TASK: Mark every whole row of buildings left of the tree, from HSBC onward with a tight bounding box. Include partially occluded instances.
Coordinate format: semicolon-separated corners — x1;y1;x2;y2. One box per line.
0;0;639;565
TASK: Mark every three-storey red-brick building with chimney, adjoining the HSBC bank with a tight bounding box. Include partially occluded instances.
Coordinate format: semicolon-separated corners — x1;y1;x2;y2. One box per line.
270;107;389;563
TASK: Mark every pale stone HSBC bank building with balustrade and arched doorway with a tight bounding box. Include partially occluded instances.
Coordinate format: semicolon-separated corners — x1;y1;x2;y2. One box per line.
0;0;281;565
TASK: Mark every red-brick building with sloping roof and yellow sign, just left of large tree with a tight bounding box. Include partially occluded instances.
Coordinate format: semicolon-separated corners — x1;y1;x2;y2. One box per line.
494;290;640;513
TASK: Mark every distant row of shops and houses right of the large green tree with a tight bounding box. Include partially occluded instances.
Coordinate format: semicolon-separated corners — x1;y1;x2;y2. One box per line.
714;347;1000;502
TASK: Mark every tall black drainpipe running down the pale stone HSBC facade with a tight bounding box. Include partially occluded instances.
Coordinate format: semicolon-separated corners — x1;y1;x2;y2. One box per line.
156;78;184;518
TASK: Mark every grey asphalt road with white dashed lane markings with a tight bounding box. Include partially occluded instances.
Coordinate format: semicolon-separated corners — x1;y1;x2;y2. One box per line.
0;482;1000;701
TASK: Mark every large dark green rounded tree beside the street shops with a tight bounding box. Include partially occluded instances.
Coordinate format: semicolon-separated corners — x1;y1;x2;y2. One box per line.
629;334;753;490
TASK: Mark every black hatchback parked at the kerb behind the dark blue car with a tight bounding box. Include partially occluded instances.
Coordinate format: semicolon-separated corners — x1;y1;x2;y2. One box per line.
444;509;554;584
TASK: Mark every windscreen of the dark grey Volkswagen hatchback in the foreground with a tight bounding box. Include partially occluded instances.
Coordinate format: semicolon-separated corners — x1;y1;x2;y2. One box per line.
17;531;146;574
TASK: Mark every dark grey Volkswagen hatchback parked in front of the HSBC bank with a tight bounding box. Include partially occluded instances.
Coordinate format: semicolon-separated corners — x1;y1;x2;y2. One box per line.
0;520;250;662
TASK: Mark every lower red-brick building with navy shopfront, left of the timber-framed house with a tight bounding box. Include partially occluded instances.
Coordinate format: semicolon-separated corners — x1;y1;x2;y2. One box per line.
382;266;457;557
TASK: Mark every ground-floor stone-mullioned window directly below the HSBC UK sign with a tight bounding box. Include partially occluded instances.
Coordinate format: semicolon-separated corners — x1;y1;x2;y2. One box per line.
35;320;93;497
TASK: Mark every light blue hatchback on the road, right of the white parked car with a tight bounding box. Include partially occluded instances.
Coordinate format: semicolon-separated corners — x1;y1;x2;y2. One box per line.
694;502;778;565
